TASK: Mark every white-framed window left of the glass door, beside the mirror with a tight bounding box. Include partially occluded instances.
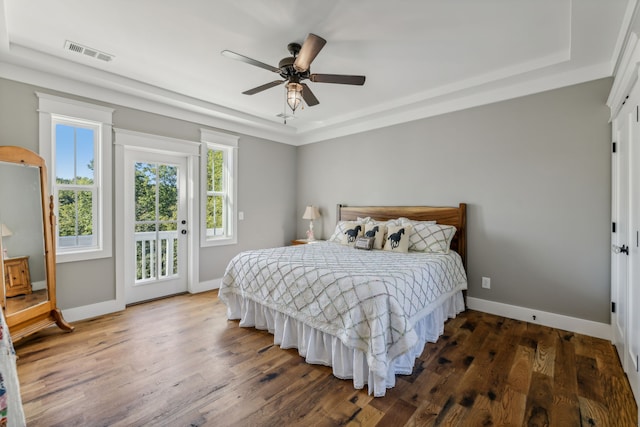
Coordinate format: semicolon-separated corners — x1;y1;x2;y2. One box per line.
37;93;113;262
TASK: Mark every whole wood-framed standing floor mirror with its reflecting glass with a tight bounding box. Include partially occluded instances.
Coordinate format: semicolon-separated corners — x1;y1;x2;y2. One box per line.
0;146;73;342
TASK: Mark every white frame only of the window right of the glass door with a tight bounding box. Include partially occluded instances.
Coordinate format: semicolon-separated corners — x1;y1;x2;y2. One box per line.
200;129;239;247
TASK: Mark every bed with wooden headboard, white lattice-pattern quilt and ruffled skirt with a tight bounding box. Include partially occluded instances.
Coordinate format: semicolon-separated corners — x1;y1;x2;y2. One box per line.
219;203;467;397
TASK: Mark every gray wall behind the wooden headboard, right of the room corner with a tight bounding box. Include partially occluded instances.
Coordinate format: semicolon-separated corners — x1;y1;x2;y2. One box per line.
298;79;612;323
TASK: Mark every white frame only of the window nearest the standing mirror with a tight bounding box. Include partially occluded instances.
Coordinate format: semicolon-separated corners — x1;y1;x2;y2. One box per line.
36;92;114;263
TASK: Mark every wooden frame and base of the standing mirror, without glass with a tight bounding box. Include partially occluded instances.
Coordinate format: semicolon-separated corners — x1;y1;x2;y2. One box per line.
0;146;74;342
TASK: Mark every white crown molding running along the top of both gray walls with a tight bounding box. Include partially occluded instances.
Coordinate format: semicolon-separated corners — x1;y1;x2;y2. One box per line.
0;42;612;146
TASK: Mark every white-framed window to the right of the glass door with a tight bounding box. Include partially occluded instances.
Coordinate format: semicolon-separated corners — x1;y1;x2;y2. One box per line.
200;129;238;246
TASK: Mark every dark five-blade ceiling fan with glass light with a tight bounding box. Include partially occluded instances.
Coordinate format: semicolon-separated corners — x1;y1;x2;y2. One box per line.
221;33;365;111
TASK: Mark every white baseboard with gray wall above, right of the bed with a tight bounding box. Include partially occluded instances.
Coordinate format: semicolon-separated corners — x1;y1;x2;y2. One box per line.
467;297;612;341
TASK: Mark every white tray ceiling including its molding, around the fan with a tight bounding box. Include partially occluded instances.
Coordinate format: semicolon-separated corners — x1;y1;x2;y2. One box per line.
0;0;636;145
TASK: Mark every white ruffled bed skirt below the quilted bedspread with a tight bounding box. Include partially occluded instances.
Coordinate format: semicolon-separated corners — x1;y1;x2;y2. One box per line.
227;291;464;397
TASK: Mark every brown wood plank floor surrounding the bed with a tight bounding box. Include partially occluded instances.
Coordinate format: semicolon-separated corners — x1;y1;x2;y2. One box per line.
16;291;638;427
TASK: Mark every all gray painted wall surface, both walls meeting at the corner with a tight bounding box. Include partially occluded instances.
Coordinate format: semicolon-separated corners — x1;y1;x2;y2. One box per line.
0;79;612;323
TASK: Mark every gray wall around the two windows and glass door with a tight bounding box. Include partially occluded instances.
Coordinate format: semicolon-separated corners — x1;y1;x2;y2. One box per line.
0;79;297;309
